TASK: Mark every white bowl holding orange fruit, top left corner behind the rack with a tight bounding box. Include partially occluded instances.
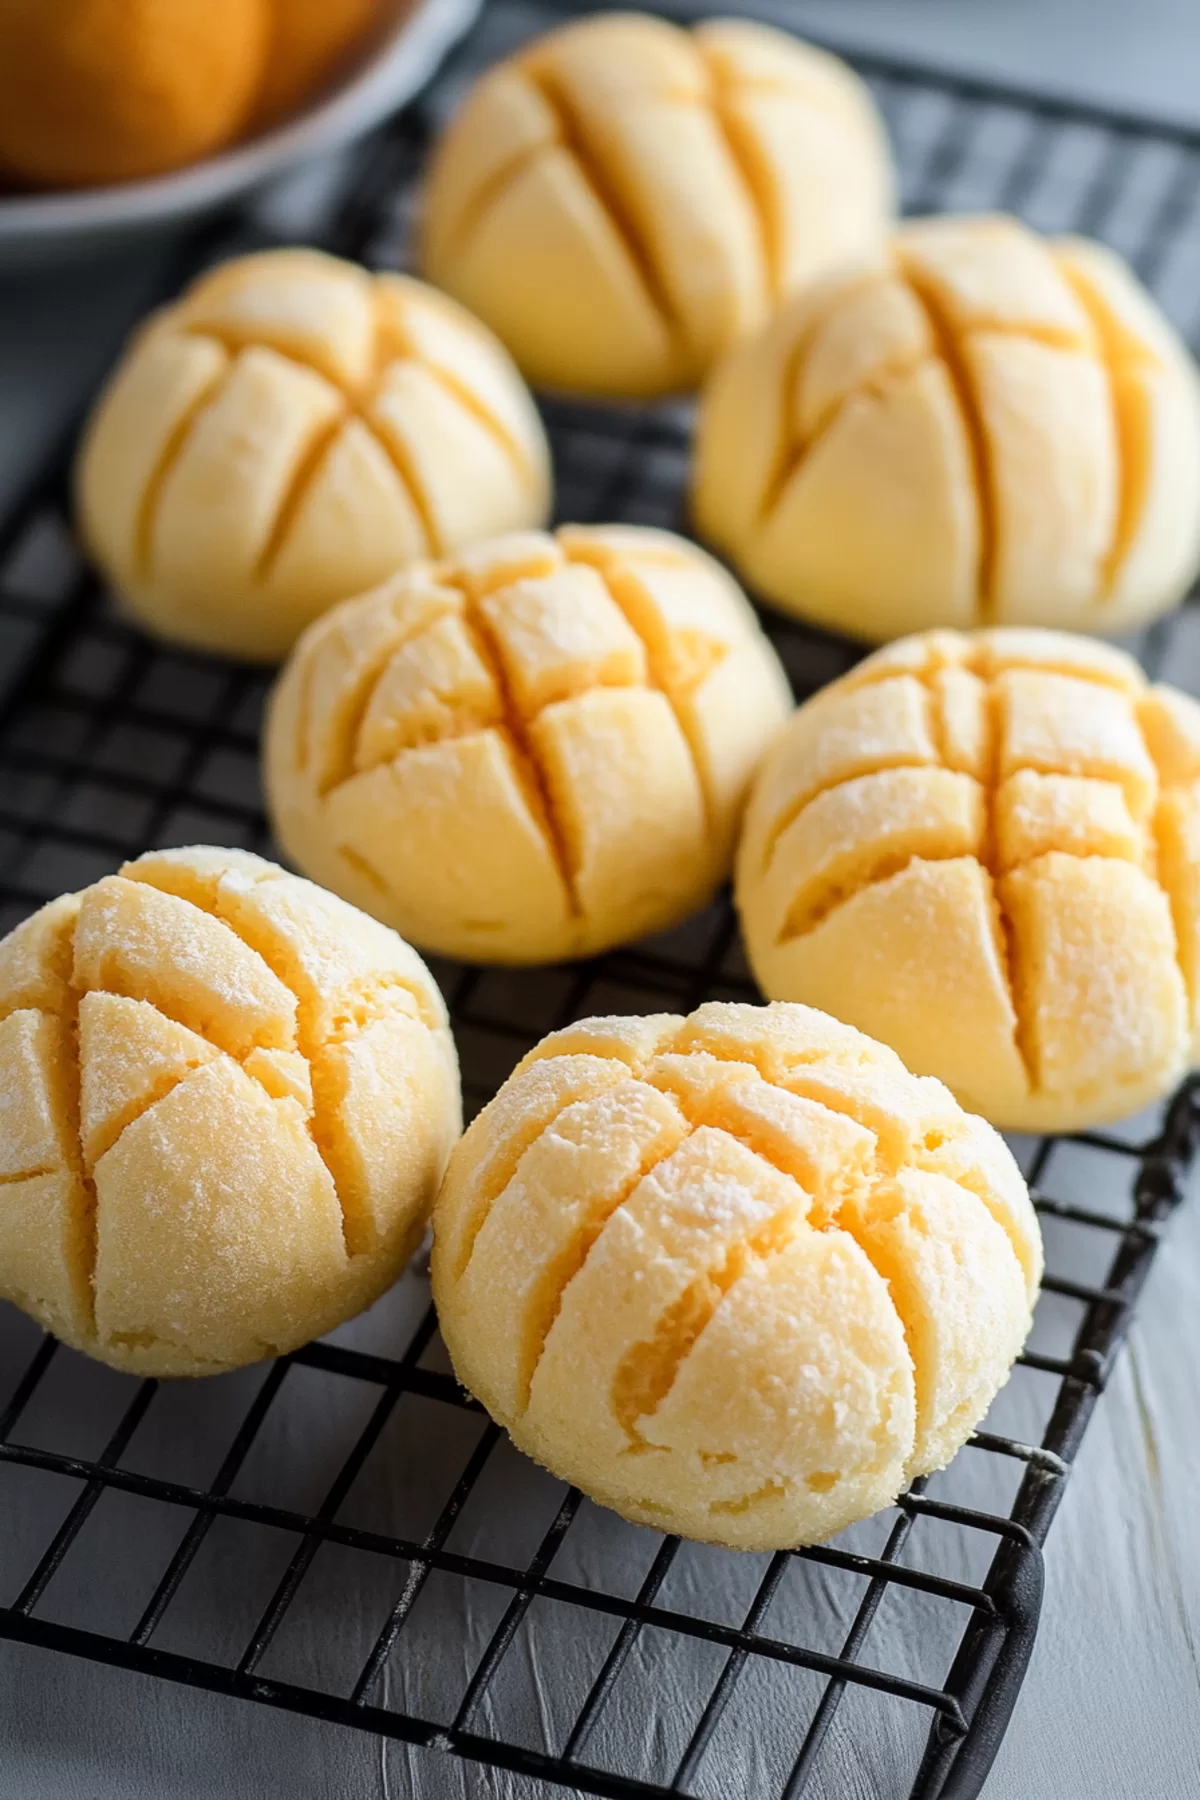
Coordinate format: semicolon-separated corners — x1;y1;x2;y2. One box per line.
0;0;480;270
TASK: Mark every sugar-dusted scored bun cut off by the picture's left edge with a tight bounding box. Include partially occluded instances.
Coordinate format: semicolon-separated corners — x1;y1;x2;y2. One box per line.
0;848;461;1375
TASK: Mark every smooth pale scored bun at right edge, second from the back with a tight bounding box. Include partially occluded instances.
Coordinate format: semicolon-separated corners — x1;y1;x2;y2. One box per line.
693;218;1200;641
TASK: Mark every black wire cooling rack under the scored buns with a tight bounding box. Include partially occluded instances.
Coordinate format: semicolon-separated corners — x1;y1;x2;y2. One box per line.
0;5;1200;1800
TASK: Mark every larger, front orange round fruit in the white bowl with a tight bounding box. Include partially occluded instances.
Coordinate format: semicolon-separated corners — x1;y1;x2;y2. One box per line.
0;0;271;187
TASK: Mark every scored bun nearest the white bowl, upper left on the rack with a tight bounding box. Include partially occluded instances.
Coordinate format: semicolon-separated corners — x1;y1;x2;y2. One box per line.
77;250;551;659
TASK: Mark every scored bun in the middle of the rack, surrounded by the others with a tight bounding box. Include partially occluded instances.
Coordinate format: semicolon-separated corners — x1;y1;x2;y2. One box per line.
264;526;790;963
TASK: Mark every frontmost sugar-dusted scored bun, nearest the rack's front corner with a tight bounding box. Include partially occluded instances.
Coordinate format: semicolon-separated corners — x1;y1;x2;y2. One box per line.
434;1003;1042;1550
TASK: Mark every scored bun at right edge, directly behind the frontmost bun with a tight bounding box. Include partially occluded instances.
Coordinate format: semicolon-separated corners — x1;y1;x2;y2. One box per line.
738;630;1200;1130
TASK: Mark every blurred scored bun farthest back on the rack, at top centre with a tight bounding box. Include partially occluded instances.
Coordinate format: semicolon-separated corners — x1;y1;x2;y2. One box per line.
421;13;892;396
